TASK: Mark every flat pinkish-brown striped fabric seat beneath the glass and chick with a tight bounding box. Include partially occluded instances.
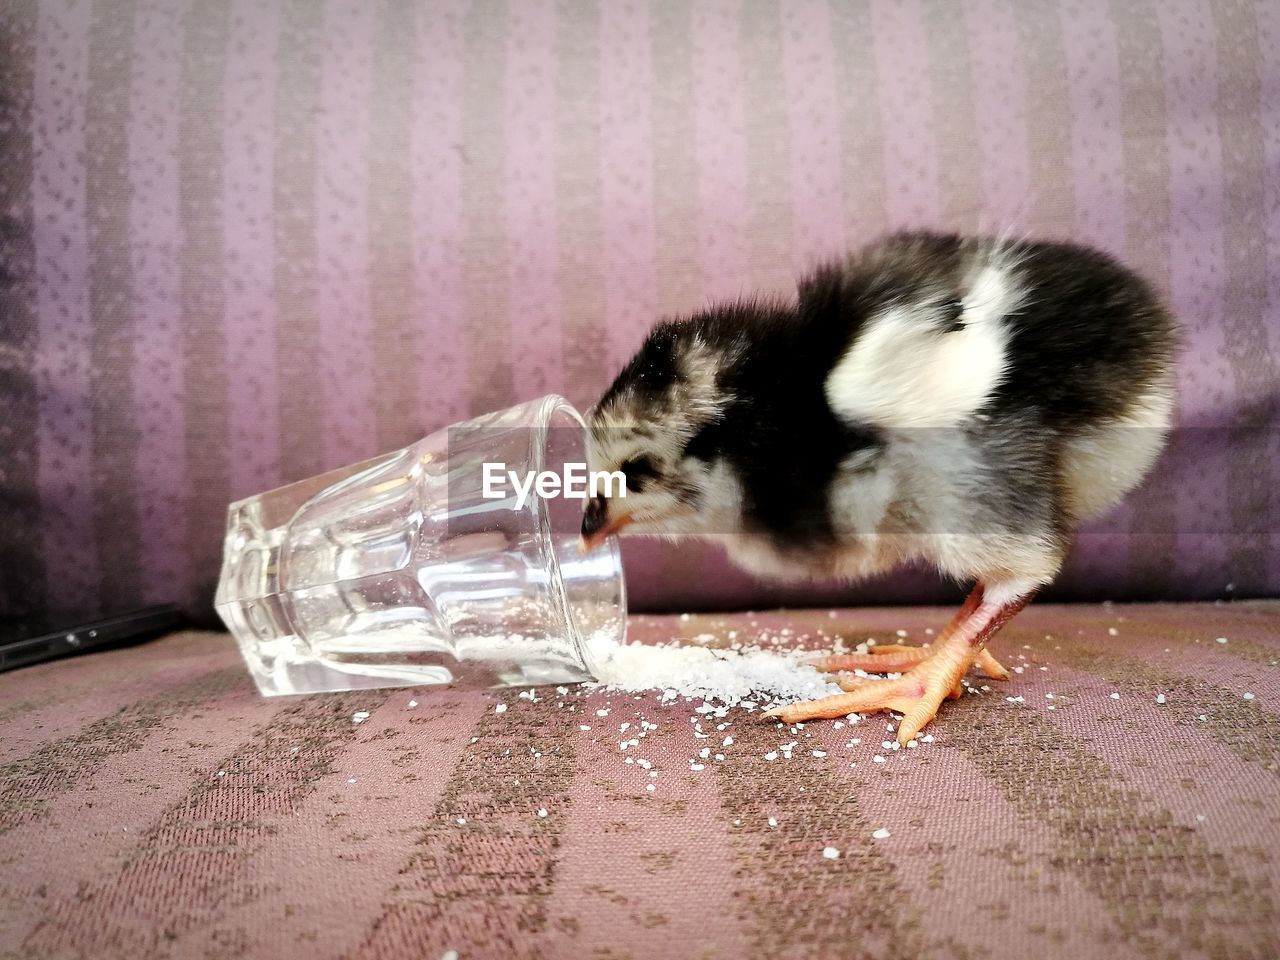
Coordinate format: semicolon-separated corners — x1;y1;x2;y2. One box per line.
0;603;1280;960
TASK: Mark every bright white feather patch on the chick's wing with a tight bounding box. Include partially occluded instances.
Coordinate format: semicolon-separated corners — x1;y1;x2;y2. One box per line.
824;264;1020;428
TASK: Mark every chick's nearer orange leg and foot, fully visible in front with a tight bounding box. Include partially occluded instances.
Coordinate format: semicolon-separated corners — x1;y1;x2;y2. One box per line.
765;585;1032;744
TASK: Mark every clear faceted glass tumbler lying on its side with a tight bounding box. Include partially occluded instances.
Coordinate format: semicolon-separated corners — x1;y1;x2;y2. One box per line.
215;397;626;696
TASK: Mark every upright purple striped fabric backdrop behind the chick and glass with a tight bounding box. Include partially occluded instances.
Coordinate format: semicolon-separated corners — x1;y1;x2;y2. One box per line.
0;0;1280;624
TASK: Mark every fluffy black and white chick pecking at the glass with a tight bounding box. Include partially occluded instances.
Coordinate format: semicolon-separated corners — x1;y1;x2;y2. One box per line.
582;233;1178;744
